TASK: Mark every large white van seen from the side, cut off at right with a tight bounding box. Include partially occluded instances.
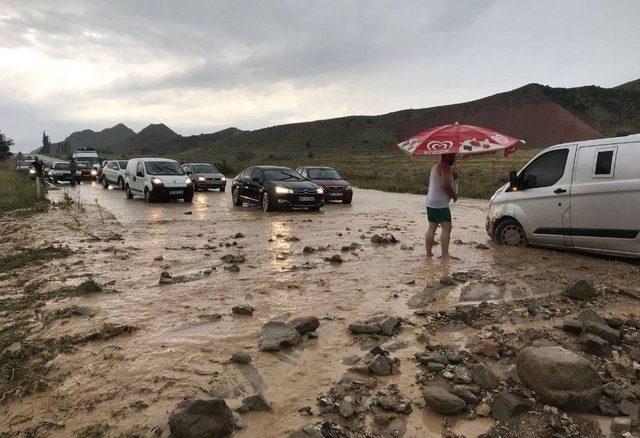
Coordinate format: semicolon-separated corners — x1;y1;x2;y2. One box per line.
486;134;640;257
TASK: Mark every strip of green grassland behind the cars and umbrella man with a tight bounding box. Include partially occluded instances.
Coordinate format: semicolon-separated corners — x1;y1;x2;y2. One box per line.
178;144;539;199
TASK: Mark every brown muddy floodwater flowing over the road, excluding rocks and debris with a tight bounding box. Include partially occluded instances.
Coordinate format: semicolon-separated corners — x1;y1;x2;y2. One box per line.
0;184;639;437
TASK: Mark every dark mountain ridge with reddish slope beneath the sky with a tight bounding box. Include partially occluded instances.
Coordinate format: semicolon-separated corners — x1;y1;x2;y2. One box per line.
46;80;640;155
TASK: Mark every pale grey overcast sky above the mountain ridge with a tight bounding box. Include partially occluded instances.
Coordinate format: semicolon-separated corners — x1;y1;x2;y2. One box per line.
0;0;640;150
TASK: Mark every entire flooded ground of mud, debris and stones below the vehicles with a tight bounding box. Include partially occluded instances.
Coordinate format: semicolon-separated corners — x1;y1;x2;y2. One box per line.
0;188;640;437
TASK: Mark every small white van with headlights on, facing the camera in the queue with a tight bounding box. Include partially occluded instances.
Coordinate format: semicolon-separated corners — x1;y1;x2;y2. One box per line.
124;158;193;202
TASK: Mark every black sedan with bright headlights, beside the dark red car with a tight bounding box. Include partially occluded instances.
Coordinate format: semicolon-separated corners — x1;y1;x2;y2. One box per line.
231;166;324;211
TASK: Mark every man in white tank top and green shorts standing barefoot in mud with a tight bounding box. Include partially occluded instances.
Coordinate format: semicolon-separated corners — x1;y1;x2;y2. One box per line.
425;154;458;259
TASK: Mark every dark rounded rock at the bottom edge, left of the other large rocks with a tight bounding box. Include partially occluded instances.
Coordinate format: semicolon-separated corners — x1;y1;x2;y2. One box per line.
169;398;234;438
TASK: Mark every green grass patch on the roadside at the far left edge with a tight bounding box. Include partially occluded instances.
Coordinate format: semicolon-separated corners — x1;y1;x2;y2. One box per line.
0;160;47;216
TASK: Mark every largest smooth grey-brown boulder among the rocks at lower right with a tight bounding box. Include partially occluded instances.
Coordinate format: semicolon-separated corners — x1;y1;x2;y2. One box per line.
516;347;601;412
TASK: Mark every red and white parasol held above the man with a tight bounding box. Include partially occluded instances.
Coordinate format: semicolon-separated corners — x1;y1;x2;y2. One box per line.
394;122;524;159
